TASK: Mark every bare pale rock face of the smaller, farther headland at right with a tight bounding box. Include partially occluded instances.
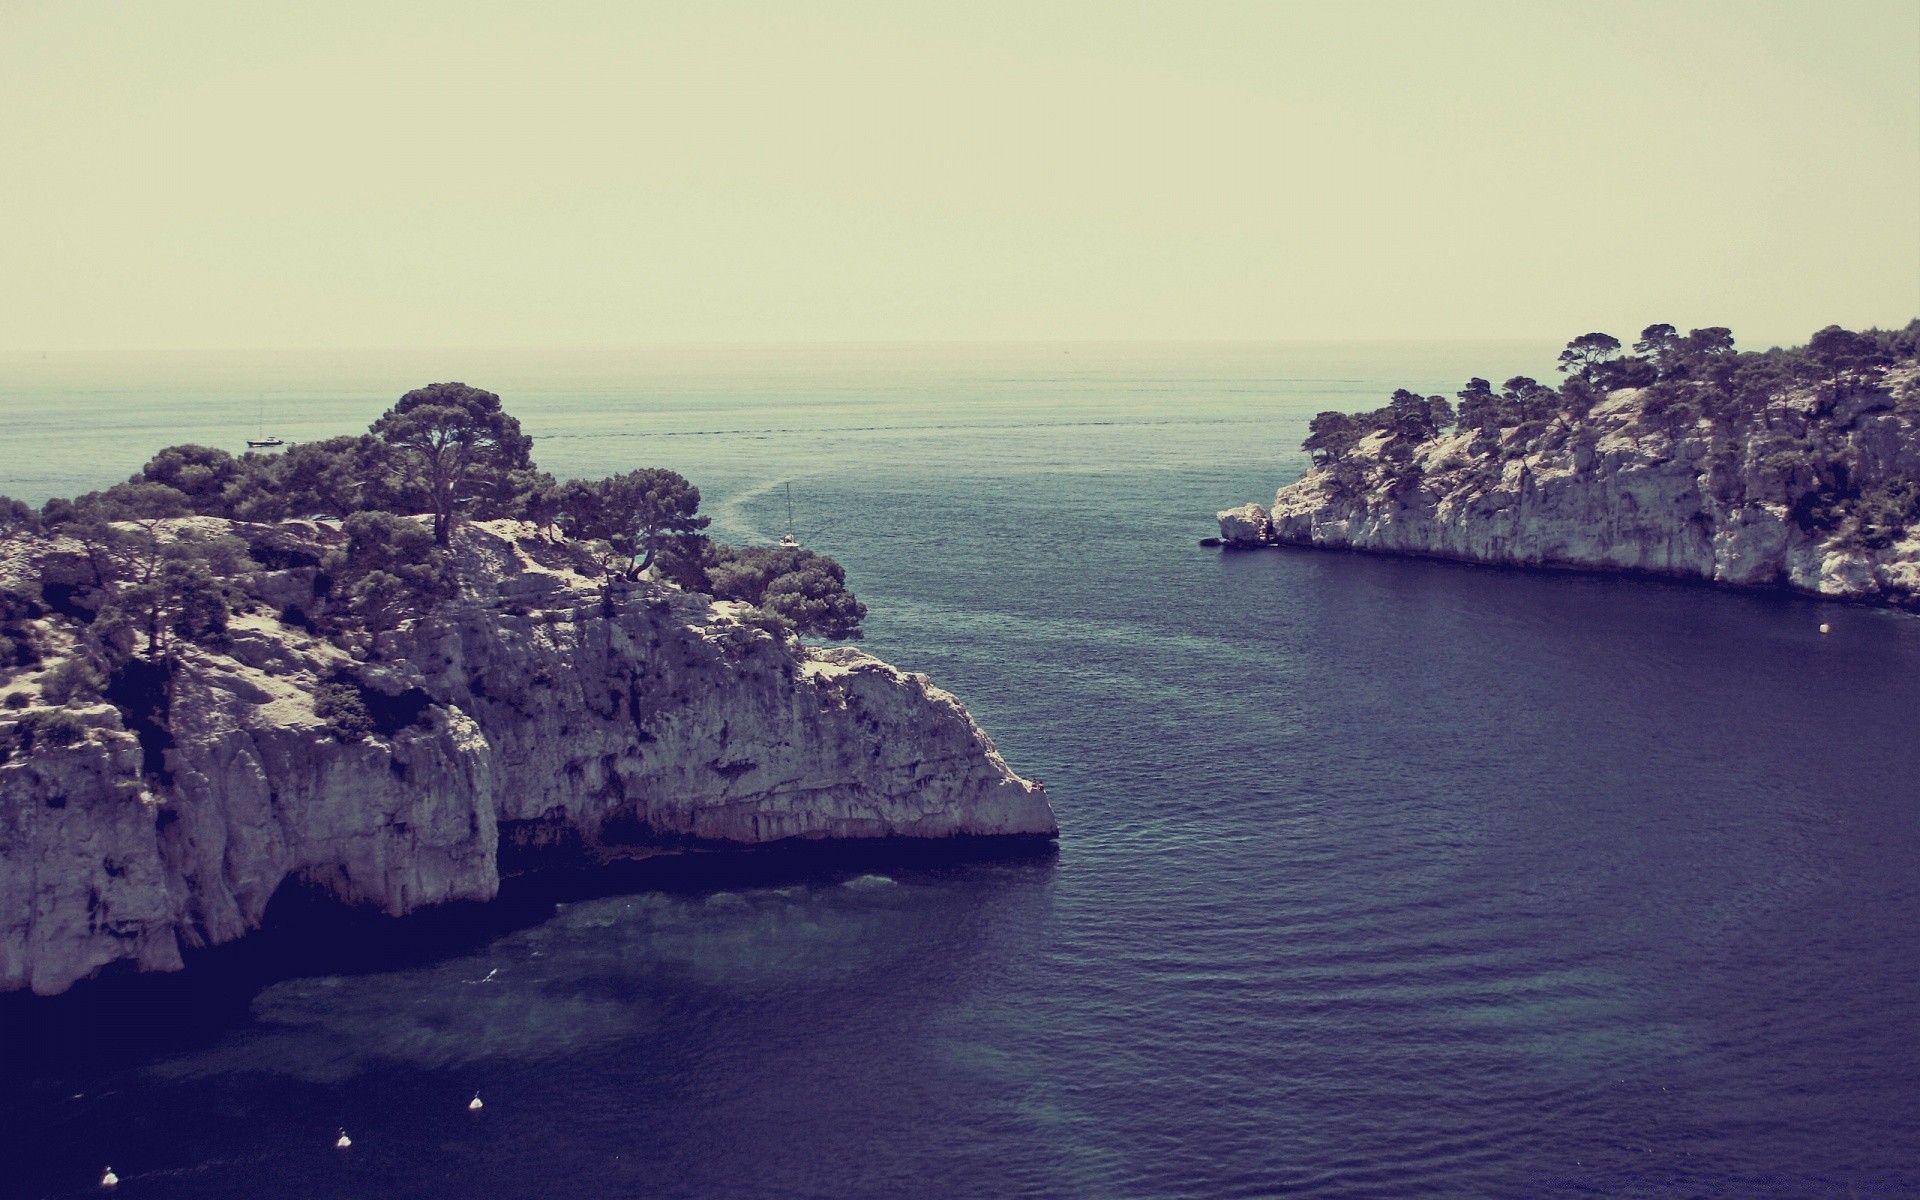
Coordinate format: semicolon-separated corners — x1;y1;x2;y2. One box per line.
1219;365;1920;607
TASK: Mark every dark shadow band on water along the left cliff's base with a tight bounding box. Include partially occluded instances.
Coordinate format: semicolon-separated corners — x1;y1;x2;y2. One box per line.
0;837;1058;1081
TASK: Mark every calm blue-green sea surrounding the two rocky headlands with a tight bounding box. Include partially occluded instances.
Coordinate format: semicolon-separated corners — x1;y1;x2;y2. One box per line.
0;346;1920;1198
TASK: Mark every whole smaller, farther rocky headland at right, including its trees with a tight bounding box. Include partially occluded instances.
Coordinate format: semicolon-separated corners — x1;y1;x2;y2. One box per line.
1219;323;1920;607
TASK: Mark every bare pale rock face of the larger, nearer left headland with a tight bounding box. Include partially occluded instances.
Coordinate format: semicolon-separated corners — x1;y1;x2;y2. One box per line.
0;518;1056;993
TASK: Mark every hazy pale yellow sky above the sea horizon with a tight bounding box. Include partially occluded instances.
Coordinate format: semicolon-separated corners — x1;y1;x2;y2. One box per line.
0;0;1920;351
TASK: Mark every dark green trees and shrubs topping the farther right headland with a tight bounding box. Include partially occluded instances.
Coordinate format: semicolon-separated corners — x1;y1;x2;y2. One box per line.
1302;321;1920;549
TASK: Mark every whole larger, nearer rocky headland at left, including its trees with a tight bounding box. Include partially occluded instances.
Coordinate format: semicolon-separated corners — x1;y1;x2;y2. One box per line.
0;386;1056;995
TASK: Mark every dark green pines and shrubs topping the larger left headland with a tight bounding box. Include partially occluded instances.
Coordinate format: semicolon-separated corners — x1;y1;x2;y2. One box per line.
0;384;866;691
